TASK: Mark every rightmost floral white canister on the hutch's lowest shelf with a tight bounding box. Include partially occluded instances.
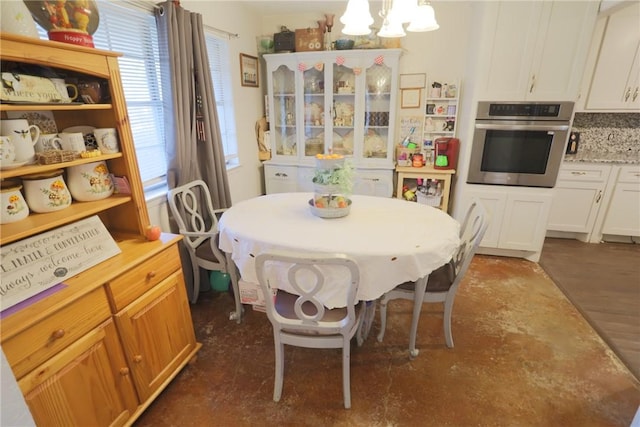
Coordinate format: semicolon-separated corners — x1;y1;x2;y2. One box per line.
67;161;114;202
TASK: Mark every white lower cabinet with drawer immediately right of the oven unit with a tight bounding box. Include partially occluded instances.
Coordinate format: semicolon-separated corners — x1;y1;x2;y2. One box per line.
547;163;611;241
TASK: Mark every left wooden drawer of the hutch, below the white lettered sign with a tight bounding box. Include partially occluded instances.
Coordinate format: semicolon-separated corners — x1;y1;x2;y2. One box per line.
2;287;111;379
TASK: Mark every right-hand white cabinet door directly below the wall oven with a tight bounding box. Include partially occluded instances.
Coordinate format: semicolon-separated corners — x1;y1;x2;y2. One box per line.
498;192;551;251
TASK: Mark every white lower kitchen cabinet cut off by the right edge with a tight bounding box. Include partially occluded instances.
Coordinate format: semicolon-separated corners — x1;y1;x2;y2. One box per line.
602;165;640;237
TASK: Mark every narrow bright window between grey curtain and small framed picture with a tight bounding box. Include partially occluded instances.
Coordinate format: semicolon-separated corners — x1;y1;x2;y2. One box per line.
205;33;239;167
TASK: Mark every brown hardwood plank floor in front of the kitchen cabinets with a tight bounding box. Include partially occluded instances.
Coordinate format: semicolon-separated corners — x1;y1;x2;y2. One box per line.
540;238;640;379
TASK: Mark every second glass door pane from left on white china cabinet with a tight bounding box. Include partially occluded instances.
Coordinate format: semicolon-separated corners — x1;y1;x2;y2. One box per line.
303;67;324;156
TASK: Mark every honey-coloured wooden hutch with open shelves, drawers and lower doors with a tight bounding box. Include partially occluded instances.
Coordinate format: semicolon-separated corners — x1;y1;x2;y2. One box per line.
0;34;201;426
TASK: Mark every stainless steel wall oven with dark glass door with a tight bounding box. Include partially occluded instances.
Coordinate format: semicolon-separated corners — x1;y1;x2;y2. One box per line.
467;102;573;187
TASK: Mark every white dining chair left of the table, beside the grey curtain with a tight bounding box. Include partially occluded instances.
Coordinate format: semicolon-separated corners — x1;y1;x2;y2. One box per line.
167;180;242;321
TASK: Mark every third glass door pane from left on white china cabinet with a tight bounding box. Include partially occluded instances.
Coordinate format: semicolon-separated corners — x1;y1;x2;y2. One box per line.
331;64;356;156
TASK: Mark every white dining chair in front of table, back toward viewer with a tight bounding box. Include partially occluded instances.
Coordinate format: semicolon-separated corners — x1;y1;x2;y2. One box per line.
256;252;364;409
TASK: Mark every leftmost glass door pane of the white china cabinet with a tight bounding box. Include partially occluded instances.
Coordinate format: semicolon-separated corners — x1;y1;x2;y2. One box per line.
271;65;297;156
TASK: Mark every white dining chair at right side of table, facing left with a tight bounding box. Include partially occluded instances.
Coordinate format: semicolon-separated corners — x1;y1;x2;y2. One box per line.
378;200;488;358
